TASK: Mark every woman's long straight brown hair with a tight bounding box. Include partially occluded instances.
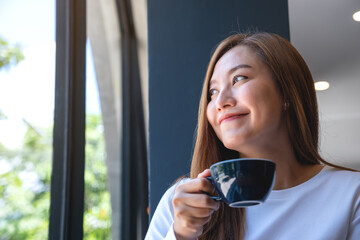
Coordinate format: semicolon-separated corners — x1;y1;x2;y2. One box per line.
190;32;334;240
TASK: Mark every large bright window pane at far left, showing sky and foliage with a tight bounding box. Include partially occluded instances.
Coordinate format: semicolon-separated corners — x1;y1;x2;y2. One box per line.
0;0;55;239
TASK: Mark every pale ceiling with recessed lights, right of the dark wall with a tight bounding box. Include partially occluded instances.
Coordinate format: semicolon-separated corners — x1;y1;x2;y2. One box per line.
288;0;360;169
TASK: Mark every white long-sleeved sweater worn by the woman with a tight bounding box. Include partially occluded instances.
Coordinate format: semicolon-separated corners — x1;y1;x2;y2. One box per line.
145;167;360;240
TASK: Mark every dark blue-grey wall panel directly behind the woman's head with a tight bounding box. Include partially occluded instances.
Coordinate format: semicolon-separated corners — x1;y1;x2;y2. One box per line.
148;0;289;218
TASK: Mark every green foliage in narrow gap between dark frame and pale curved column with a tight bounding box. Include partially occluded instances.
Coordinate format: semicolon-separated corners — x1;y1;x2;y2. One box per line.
84;114;111;240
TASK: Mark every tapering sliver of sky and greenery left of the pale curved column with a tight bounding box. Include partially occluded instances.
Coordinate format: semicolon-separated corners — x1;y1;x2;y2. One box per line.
84;41;111;240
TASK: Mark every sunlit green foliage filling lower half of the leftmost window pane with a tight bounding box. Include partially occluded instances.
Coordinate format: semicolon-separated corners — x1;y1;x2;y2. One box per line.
0;122;51;240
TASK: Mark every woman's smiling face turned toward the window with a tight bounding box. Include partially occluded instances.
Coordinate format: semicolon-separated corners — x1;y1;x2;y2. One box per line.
207;46;287;153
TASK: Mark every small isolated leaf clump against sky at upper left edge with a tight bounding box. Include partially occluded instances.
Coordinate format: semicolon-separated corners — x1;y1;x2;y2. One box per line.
0;36;24;69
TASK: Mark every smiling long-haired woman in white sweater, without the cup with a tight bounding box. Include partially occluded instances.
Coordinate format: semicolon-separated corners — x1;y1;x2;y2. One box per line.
146;33;360;240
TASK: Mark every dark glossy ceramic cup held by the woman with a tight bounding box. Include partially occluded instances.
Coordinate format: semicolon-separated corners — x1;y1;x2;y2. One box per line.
207;158;276;208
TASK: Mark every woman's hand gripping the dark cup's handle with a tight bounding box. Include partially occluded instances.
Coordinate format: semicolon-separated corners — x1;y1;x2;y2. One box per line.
172;169;219;239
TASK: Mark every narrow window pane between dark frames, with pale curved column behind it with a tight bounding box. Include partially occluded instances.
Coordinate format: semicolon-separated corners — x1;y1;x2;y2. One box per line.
84;0;122;239
